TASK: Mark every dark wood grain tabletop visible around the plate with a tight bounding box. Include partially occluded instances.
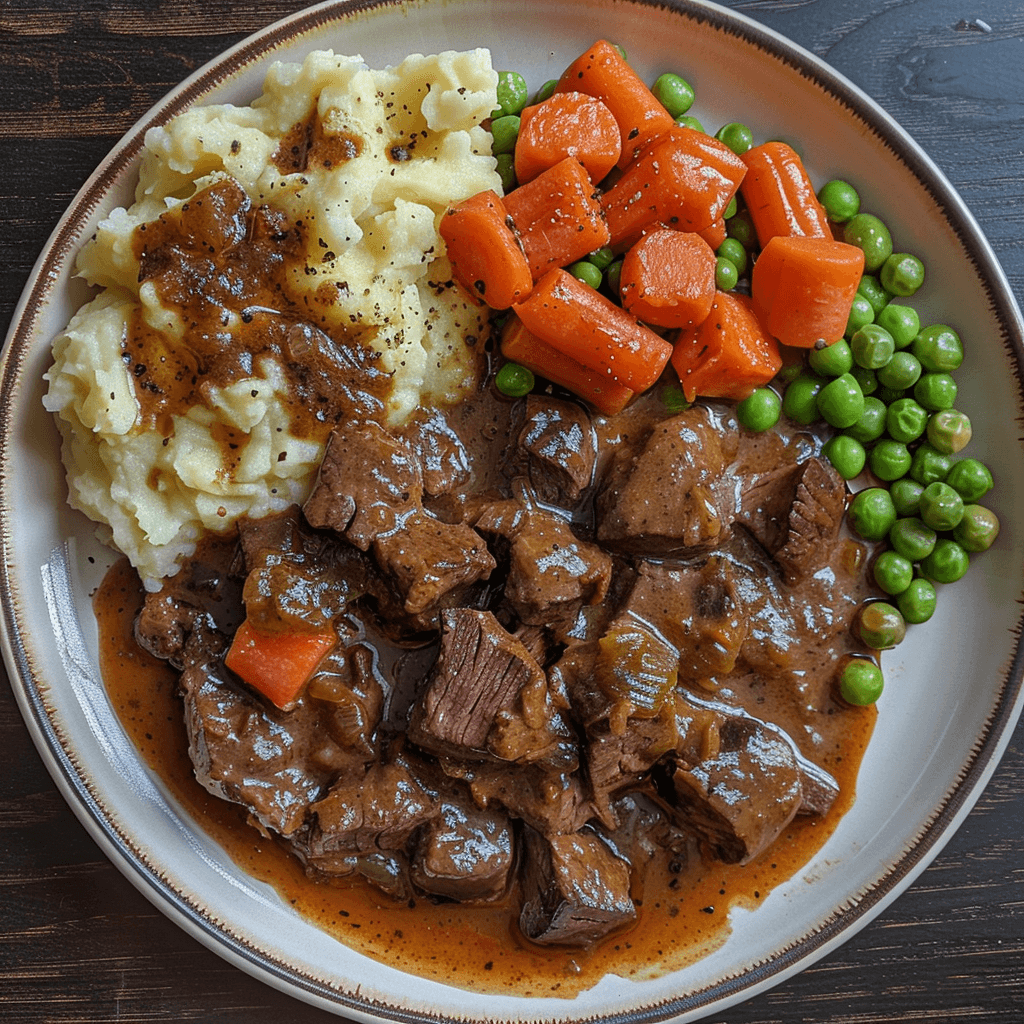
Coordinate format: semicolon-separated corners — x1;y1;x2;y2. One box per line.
0;0;1024;1024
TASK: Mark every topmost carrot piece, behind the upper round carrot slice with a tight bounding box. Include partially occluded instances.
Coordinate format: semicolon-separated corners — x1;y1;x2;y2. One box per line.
555;39;675;167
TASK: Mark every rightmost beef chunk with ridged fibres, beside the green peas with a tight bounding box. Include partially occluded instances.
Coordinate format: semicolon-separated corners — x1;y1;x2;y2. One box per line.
738;458;846;583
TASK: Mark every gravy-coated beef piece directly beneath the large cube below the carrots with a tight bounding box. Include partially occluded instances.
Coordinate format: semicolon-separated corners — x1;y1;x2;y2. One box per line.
612;555;748;680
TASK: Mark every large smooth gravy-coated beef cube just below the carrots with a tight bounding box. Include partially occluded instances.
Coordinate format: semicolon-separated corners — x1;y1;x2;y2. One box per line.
597;407;735;557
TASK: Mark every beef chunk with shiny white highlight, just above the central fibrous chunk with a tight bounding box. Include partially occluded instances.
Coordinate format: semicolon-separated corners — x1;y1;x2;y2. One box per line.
474;500;612;638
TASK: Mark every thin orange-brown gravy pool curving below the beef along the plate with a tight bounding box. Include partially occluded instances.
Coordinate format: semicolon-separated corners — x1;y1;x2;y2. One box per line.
94;560;876;997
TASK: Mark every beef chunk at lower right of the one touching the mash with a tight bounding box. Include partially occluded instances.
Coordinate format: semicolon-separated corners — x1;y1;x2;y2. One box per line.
374;510;495;615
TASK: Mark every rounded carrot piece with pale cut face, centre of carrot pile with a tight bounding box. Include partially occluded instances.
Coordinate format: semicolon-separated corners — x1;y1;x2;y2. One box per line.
620;228;716;327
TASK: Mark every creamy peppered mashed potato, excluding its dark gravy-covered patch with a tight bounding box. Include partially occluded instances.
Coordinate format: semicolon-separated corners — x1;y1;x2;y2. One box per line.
44;49;501;586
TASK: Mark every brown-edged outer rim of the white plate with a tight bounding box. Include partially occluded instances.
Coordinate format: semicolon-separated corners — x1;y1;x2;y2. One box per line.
0;0;1024;1024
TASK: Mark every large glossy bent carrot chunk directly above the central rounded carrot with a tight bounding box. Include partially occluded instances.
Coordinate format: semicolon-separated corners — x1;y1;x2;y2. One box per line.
601;125;746;246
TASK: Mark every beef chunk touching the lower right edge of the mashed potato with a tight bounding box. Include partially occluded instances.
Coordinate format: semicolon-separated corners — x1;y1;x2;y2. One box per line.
303;420;423;551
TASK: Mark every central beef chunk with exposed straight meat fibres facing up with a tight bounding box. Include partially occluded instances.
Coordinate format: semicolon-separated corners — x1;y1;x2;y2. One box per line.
409;608;569;762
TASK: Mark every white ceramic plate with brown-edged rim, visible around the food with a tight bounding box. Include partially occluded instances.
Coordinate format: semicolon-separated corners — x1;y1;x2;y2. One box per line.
0;0;1024;1021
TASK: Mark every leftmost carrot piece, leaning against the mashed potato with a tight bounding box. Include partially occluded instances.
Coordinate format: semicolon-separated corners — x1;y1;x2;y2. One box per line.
437;190;534;309
